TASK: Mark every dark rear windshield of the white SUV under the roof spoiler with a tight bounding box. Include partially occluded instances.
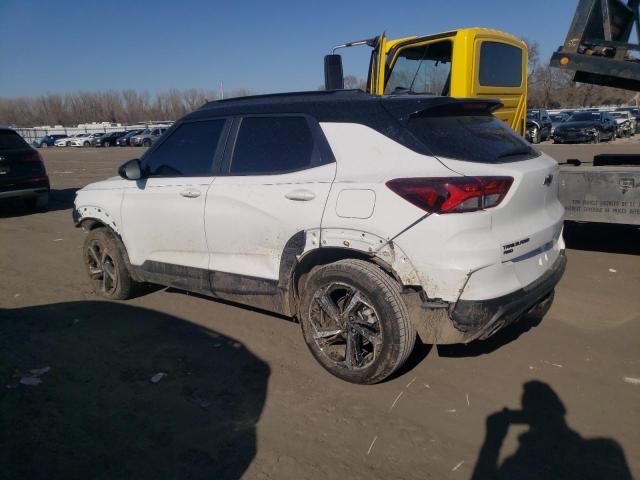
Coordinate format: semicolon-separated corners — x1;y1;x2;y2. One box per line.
407;116;540;163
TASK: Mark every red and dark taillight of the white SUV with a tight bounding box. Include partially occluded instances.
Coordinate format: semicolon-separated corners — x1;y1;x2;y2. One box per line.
387;177;513;213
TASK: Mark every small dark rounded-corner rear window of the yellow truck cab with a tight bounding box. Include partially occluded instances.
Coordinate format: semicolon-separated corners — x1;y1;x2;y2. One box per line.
479;42;522;87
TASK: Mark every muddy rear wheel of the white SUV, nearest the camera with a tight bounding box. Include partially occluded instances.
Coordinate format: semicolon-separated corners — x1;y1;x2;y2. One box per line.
299;259;416;384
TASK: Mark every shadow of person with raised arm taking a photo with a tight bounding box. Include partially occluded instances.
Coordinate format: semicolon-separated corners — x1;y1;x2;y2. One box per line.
471;380;632;480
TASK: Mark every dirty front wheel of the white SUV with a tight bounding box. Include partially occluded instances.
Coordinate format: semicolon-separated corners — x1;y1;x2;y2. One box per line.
82;228;135;300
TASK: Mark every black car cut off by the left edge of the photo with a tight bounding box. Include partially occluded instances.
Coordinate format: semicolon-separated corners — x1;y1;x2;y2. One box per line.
0;127;49;209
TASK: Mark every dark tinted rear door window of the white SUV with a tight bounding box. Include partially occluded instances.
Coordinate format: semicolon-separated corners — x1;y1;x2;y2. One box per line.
229;116;321;175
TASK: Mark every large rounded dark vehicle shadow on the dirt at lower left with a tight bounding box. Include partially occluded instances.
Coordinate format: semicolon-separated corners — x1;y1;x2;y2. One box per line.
0;301;270;480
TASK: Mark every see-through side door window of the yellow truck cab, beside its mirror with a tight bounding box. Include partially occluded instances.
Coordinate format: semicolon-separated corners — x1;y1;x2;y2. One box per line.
384;40;452;95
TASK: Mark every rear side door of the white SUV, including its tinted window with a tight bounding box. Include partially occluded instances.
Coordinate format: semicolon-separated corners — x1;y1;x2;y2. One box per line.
206;115;336;282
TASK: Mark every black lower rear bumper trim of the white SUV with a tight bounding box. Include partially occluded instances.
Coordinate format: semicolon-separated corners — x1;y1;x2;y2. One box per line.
449;251;567;343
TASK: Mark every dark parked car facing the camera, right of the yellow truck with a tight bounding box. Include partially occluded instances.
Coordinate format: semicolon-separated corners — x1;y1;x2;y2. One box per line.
553;111;618;143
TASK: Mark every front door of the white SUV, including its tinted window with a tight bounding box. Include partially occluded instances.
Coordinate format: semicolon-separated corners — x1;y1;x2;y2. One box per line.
122;119;228;273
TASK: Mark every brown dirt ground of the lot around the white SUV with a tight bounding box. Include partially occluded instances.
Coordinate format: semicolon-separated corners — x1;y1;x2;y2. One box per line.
0;140;640;480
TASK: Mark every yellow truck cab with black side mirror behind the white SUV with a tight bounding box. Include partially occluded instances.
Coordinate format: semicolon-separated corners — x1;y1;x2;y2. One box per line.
325;28;528;136
